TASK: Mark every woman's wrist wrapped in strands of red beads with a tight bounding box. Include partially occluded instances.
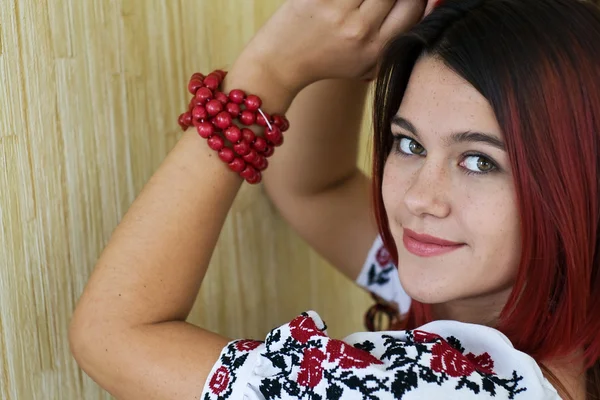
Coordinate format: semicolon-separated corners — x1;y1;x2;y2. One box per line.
178;63;294;184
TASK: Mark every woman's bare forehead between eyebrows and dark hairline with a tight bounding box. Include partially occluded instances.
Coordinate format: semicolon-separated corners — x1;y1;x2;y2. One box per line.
398;56;500;134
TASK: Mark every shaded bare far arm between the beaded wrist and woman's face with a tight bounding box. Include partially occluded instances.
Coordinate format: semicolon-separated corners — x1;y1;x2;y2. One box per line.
264;80;377;280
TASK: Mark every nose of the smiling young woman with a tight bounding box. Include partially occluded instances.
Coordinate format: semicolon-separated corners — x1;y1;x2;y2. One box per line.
404;160;450;218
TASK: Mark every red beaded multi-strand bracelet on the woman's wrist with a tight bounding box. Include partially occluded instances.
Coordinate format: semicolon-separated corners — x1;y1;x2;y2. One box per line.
179;70;289;184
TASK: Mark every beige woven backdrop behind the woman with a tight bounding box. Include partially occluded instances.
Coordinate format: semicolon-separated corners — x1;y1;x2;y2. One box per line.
0;0;370;400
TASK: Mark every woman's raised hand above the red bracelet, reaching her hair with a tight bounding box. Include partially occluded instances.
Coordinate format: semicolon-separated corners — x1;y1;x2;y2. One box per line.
240;0;427;91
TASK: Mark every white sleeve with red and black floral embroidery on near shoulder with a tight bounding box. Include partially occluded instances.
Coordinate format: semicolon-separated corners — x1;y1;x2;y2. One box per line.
202;311;559;400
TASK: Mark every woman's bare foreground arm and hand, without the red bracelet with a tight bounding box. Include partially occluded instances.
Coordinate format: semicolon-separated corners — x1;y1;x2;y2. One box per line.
69;0;424;400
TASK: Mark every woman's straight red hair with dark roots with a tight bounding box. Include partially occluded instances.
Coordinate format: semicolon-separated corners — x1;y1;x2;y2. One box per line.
373;0;600;376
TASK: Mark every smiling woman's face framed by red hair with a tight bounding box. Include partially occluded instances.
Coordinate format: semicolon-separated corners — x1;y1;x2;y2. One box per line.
382;57;520;318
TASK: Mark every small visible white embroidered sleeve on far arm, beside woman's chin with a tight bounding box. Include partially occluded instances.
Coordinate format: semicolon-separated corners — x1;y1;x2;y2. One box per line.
356;236;411;314
